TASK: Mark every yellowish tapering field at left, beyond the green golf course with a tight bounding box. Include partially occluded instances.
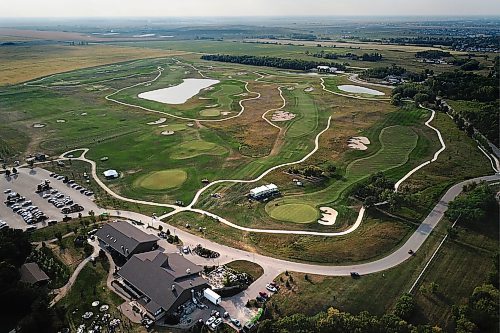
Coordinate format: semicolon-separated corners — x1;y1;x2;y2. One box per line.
0;45;179;86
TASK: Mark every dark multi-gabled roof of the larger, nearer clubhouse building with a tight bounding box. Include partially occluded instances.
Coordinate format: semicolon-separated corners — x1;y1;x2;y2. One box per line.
118;251;208;313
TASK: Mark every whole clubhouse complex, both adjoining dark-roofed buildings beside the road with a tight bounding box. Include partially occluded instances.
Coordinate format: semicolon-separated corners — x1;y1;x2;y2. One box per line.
95;221;210;320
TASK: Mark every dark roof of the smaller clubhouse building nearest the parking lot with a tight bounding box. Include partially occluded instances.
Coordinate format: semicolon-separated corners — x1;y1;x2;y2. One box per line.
96;221;159;253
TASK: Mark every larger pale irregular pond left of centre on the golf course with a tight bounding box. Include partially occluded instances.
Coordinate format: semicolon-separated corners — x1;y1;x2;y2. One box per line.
139;79;220;104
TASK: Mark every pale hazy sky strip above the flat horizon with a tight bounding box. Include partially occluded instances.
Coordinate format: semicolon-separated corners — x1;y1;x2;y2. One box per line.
0;0;500;18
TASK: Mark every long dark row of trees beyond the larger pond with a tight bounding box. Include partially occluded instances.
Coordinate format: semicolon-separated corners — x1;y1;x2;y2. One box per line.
201;54;346;70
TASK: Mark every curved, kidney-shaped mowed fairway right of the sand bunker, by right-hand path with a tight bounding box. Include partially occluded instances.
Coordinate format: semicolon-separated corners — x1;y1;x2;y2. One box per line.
346;125;418;178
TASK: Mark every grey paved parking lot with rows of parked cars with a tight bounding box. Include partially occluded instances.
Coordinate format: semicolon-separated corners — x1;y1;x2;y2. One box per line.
0;168;97;230
